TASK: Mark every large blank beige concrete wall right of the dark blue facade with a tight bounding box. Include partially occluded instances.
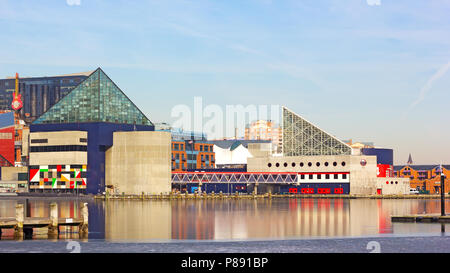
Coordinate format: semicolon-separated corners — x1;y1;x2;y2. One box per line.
105;131;171;194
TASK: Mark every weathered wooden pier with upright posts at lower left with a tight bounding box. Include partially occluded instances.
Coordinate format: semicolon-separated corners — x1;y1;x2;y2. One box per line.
0;203;89;239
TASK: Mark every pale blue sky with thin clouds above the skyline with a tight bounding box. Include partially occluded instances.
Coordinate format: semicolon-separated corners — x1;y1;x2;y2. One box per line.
0;0;450;164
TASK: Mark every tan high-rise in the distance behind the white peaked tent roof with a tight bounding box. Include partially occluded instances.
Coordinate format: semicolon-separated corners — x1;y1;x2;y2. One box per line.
244;120;282;153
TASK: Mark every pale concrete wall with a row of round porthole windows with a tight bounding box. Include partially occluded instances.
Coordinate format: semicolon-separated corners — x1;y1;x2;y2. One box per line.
247;155;377;194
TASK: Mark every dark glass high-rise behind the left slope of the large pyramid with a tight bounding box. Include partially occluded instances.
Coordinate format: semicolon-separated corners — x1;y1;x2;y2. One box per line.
0;71;92;123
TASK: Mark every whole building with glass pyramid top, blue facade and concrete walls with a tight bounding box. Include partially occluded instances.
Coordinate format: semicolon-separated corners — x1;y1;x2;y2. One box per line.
29;68;170;194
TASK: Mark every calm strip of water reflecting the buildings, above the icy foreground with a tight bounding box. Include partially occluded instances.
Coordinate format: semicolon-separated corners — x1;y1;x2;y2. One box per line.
0;199;450;241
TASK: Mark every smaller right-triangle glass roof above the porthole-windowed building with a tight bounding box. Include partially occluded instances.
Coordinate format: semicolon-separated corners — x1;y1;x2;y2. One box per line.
282;107;352;156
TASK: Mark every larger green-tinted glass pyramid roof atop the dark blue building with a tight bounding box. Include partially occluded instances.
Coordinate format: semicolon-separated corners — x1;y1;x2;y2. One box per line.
33;68;153;125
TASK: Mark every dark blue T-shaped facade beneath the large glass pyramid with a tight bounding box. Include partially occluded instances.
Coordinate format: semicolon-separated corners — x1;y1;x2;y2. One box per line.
30;122;154;194
